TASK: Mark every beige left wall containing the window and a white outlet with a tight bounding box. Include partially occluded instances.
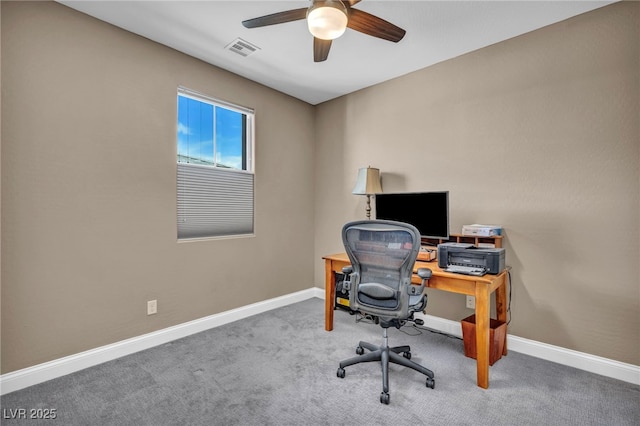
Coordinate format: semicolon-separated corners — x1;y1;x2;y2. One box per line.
1;2;315;373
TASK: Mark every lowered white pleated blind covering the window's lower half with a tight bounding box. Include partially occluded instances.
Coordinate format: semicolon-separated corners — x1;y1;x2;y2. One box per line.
177;163;254;239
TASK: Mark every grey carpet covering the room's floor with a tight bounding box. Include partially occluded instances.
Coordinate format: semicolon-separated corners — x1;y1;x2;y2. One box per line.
0;299;640;426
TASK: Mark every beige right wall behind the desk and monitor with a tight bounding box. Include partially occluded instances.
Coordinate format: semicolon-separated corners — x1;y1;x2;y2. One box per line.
315;2;640;365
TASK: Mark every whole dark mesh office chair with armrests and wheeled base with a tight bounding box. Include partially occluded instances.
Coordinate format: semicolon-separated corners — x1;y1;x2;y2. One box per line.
338;220;435;404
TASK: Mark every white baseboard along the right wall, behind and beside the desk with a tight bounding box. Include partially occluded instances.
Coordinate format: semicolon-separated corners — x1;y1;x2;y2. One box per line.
416;315;640;385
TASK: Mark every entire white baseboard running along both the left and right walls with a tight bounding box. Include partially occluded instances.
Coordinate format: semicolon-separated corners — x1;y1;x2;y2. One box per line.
0;287;640;395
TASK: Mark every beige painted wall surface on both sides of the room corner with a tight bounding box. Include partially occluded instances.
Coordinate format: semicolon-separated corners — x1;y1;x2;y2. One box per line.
0;2;640;373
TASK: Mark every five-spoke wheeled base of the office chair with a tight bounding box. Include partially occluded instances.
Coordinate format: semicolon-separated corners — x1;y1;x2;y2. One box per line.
337;329;435;404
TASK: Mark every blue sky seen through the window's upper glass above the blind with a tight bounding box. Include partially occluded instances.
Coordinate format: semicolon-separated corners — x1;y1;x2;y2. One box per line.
177;95;244;170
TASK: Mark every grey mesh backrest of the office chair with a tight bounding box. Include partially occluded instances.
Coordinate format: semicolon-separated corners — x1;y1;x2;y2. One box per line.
342;220;420;318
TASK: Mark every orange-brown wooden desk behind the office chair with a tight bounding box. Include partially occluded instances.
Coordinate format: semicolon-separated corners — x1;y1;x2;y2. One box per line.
323;253;507;389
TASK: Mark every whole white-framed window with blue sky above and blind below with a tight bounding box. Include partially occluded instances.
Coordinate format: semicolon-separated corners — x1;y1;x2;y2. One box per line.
177;87;254;239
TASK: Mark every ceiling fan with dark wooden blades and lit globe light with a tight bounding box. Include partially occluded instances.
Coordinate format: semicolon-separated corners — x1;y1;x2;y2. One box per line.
242;0;406;62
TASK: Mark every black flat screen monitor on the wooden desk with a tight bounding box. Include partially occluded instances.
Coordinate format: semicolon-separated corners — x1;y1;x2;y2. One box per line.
376;191;449;239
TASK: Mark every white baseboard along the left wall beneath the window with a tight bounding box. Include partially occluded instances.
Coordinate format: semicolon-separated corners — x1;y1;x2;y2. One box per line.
0;287;324;395
